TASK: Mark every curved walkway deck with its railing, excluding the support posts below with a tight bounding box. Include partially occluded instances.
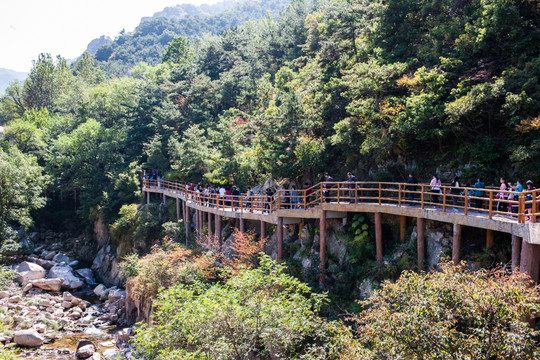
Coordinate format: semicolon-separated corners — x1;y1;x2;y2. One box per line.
142;179;540;244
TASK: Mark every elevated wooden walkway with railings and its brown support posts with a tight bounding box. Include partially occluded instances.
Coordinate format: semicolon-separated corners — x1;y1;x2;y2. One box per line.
142;179;540;281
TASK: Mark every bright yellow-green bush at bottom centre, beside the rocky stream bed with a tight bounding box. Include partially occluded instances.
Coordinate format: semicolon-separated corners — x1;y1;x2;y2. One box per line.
133;255;353;360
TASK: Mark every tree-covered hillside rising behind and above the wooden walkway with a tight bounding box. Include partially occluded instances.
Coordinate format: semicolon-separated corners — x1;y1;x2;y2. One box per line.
0;0;540;239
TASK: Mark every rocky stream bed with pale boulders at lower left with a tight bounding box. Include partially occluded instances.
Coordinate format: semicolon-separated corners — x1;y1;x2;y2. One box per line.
0;232;133;360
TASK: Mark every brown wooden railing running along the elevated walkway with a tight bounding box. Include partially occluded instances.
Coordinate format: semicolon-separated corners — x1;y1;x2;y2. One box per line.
143;179;540;223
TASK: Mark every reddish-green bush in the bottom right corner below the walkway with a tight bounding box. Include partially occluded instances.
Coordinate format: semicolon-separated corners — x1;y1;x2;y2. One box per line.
353;262;540;360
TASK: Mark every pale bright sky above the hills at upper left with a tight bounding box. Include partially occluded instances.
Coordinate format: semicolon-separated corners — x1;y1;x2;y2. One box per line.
0;0;220;72
